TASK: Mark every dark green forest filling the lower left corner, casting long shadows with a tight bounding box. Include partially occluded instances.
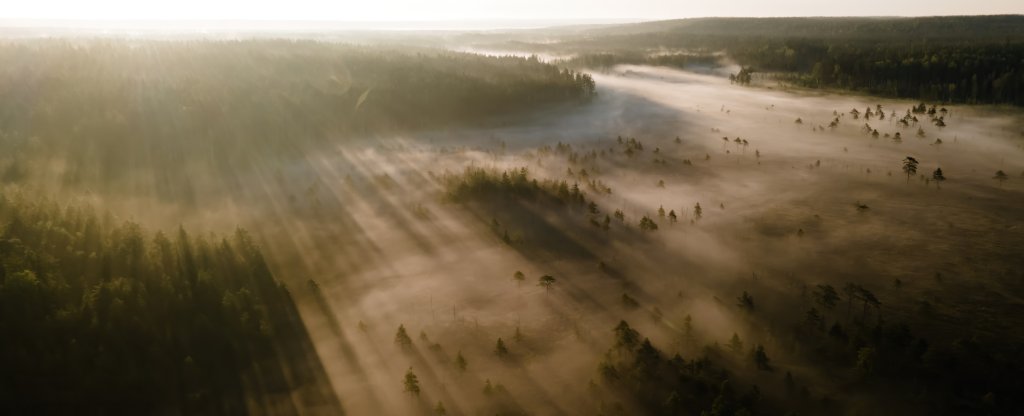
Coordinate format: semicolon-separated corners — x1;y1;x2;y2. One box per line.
0;193;340;414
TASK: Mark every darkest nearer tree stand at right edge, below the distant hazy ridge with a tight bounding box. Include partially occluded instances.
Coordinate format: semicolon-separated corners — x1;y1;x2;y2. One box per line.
730;40;1024;106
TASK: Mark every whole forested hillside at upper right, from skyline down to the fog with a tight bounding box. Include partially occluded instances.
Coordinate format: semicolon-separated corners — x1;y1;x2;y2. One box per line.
467;15;1024;106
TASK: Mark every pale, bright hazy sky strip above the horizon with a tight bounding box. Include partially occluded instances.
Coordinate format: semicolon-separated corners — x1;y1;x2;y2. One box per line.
0;0;1024;20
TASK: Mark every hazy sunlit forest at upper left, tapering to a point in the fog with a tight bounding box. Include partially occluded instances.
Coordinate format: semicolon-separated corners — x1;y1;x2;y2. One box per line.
0;39;595;199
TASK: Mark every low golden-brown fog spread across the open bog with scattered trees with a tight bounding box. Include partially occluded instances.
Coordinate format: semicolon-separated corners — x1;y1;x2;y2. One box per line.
61;60;1024;415
